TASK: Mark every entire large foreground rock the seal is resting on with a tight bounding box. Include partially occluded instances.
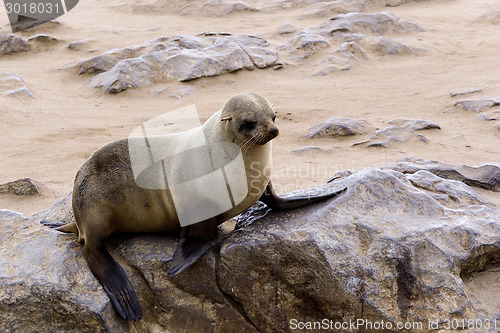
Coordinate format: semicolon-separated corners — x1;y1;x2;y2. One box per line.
0;159;500;332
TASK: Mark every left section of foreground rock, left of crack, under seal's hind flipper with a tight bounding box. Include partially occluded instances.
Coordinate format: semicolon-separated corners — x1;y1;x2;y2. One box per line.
0;195;256;332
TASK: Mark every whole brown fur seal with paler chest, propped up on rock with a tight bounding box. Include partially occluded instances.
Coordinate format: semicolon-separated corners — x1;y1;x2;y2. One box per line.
42;93;345;321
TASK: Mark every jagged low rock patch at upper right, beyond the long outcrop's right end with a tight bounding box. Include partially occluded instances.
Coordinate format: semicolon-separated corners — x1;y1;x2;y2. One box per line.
278;12;425;72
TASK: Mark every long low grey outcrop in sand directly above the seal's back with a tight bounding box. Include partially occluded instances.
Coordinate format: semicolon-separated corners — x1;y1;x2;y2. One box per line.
66;33;277;93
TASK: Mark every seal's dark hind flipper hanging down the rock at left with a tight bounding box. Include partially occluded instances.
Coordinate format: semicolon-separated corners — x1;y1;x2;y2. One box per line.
85;242;142;321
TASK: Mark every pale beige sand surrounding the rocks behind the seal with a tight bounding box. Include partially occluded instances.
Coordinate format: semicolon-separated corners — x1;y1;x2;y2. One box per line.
0;0;500;215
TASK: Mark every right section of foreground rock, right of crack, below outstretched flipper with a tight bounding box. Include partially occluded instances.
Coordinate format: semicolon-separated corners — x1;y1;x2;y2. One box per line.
228;168;500;332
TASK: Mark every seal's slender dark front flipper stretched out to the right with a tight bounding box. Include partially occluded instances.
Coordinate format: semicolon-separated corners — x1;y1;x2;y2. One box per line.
259;182;347;210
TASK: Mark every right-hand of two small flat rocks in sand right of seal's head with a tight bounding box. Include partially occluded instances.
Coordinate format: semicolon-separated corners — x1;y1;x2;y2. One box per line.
354;119;441;148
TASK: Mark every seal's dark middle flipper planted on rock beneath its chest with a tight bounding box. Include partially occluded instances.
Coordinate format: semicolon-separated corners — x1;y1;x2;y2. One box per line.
168;218;218;276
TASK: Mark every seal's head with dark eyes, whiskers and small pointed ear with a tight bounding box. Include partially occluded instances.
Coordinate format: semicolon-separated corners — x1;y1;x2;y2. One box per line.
221;93;279;146
